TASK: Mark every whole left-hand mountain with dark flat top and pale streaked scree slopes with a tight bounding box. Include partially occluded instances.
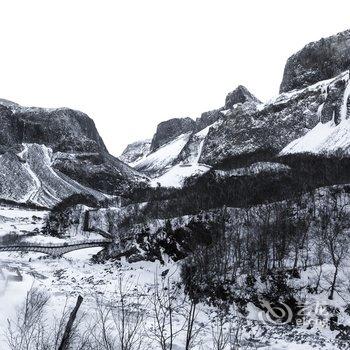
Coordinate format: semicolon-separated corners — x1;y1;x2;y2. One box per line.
0;100;146;207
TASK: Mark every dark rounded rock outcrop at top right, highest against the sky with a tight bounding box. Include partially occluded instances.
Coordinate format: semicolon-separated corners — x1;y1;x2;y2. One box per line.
280;30;350;93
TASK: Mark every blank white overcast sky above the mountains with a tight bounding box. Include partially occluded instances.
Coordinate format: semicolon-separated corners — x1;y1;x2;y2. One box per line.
0;0;350;155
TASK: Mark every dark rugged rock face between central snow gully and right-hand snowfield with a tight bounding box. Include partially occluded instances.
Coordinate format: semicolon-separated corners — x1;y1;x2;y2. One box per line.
200;81;325;165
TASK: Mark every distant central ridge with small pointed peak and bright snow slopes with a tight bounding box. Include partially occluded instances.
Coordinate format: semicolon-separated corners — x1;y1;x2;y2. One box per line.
123;85;261;187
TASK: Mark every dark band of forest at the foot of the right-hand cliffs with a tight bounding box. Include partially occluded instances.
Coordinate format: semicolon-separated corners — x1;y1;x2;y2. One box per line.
131;152;350;221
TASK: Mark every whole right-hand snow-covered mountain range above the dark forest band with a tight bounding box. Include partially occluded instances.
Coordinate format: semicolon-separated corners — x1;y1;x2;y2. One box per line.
122;31;350;187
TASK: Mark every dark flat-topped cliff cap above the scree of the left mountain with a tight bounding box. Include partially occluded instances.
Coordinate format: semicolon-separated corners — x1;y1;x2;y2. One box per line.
0;102;107;152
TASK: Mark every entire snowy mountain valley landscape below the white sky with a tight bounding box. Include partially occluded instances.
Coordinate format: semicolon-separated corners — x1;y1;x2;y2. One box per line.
4;31;350;350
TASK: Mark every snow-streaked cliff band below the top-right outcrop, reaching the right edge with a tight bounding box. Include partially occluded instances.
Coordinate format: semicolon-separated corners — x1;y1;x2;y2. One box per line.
200;72;349;165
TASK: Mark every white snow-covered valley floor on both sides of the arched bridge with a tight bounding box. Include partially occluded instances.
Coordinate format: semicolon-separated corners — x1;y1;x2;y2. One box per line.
0;206;350;350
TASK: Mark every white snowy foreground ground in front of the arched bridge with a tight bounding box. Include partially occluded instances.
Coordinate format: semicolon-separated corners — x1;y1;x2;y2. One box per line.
0;248;346;350
